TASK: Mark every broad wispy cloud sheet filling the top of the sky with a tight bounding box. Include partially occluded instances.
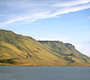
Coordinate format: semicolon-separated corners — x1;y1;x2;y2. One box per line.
0;0;90;25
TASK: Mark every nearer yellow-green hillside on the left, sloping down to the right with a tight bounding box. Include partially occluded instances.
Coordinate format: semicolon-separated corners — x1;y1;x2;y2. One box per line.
0;30;66;65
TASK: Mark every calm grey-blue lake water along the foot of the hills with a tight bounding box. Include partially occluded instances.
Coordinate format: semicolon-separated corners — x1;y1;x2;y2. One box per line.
0;66;90;80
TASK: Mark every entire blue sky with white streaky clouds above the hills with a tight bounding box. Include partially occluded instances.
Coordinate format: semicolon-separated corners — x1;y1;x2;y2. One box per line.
0;0;90;57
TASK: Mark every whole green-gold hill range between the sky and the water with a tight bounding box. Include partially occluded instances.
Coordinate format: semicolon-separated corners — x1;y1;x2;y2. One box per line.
0;30;90;66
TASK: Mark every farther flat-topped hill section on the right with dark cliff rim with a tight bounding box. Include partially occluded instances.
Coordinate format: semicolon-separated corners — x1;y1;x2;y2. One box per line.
39;41;90;65
